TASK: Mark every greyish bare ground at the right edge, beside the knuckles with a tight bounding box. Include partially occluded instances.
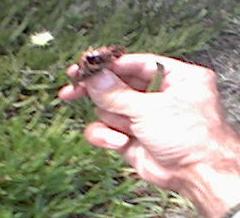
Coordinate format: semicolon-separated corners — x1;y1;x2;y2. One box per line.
186;17;240;131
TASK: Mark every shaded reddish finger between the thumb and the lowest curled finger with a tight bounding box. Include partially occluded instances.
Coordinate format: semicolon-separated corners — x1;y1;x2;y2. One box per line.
96;108;132;135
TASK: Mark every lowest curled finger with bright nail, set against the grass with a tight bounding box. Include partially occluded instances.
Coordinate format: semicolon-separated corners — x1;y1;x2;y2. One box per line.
84;122;129;150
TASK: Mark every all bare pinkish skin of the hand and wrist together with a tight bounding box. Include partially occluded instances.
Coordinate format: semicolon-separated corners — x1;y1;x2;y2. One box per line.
59;54;240;218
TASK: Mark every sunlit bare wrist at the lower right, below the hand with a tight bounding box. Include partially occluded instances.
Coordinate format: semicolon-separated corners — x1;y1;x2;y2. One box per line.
174;127;240;218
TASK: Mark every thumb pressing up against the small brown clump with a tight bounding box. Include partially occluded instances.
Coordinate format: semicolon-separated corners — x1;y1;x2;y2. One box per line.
86;69;144;117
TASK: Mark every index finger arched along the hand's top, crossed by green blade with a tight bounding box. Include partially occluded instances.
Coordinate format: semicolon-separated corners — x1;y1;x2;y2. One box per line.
110;54;212;90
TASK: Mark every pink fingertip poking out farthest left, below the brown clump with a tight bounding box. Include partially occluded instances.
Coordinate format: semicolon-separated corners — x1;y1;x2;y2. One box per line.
58;83;87;101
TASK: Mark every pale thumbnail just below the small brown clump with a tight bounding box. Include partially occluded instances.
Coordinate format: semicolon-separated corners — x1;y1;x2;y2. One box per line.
91;70;117;91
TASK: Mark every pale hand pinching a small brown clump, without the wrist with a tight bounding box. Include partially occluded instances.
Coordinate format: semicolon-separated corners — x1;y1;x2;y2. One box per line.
59;54;225;184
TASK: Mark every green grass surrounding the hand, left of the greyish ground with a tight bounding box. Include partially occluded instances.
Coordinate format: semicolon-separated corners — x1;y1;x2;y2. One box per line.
0;0;236;218
